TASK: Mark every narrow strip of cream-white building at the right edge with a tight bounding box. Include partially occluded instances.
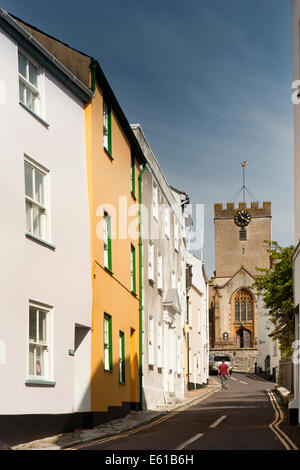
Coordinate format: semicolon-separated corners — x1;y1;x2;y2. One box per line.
289;0;300;424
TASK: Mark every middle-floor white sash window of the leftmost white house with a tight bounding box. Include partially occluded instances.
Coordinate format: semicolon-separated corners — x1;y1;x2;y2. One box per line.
24;155;51;242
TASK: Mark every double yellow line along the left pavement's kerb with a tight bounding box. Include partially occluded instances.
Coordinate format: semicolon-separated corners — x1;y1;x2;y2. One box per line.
64;388;219;450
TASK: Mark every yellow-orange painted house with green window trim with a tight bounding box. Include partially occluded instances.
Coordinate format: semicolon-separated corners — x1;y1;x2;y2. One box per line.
85;62;143;413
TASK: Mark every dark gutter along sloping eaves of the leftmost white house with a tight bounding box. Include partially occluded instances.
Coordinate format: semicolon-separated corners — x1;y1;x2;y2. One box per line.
0;7;94;98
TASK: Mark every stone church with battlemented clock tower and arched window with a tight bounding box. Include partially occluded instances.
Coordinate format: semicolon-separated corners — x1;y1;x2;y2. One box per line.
210;202;271;372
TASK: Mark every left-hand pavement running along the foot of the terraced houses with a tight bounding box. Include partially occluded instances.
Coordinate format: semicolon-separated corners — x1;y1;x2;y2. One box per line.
11;377;221;450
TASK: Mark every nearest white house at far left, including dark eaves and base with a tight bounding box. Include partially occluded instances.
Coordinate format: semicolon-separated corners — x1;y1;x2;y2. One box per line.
0;9;93;443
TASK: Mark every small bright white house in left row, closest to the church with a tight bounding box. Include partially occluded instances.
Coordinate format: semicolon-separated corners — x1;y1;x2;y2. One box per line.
187;253;209;389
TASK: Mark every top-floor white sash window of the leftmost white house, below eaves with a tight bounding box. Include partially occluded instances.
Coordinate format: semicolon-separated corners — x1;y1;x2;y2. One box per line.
18;48;45;118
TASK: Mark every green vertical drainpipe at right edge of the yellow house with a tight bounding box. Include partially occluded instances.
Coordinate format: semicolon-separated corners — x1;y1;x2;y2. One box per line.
138;165;146;411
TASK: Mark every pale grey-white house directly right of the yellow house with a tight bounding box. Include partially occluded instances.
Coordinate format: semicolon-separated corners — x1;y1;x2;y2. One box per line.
131;124;186;408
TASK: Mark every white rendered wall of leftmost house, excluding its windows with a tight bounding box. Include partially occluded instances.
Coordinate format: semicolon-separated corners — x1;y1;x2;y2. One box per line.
0;29;91;414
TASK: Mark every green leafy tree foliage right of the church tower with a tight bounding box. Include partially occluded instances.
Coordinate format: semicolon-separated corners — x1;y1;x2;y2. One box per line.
252;241;295;359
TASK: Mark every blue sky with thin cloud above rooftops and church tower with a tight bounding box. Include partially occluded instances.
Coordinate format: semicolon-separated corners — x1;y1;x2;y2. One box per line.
0;0;294;275
